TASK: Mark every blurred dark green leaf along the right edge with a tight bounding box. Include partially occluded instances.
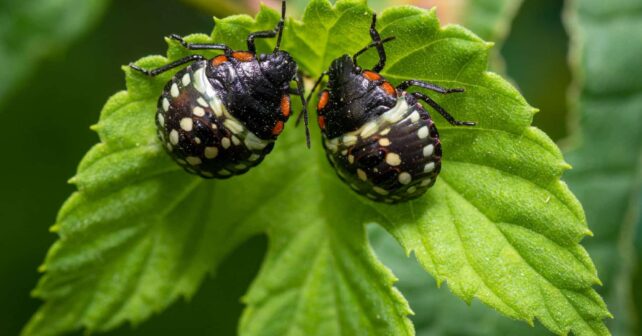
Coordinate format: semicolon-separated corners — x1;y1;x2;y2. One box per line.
567;0;642;335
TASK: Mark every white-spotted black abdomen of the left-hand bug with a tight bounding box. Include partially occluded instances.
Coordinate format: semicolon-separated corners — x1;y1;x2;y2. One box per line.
156;62;274;178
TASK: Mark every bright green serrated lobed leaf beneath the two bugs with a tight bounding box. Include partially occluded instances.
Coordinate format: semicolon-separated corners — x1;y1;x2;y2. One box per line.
24;0;609;335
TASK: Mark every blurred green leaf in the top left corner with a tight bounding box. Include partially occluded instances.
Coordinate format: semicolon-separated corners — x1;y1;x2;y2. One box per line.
0;0;108;105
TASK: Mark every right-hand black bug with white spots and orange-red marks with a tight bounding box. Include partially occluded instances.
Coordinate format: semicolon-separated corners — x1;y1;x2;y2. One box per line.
308;15;475;203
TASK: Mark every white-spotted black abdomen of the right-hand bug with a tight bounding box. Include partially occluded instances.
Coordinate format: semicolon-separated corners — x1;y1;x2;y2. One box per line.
324;95;441;203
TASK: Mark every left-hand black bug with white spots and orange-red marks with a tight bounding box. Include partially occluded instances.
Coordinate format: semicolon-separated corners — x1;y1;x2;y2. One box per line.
130;0;309;178
